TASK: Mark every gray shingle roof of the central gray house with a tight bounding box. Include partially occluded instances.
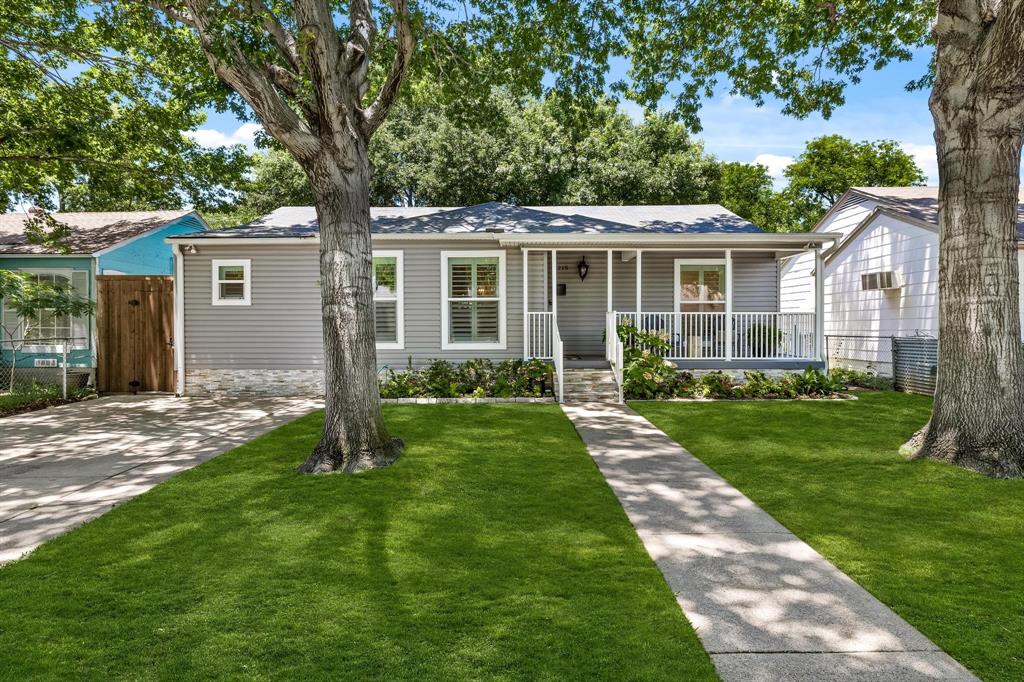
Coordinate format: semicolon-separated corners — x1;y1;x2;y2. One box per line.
176;202;762;239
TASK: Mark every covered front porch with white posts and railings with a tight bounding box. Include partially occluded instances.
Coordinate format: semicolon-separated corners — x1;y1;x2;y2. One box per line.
522;244;823;401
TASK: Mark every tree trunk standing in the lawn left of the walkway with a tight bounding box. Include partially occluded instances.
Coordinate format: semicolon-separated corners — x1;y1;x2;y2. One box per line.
299;141;402;473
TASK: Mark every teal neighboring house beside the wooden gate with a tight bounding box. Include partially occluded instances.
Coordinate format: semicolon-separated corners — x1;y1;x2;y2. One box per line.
0;211;209;380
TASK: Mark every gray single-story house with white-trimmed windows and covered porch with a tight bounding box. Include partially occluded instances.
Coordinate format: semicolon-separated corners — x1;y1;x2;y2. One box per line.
168;203;833;394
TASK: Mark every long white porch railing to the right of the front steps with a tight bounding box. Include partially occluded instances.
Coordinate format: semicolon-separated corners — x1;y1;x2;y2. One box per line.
614;312;815;360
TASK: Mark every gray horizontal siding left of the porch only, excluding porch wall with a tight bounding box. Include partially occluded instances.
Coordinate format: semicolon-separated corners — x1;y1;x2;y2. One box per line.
183;242;524;370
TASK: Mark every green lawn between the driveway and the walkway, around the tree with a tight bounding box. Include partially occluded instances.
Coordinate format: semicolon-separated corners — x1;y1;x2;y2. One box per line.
0;404;714;680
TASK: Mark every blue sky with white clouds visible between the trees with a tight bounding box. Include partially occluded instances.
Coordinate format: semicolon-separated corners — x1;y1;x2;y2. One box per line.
194;49;938;185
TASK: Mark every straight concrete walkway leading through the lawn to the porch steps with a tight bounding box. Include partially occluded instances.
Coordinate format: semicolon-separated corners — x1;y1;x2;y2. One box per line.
563;403;975;682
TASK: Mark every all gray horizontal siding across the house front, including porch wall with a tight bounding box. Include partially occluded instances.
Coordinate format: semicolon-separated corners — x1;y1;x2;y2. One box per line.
182;242;778;370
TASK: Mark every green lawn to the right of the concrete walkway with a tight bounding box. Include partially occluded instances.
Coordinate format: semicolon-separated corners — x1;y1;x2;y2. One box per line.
631;392;1024;680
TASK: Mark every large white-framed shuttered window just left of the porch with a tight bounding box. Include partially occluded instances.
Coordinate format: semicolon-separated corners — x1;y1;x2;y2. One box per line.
441;251;505;350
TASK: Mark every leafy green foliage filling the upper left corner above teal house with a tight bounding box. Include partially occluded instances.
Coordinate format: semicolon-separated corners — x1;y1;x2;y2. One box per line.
0;0;248;210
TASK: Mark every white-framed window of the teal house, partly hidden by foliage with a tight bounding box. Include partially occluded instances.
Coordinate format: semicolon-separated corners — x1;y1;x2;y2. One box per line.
0;268;90;352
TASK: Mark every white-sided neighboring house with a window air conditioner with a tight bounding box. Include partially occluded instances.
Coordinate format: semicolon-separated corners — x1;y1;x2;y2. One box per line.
779;187;1024;376
